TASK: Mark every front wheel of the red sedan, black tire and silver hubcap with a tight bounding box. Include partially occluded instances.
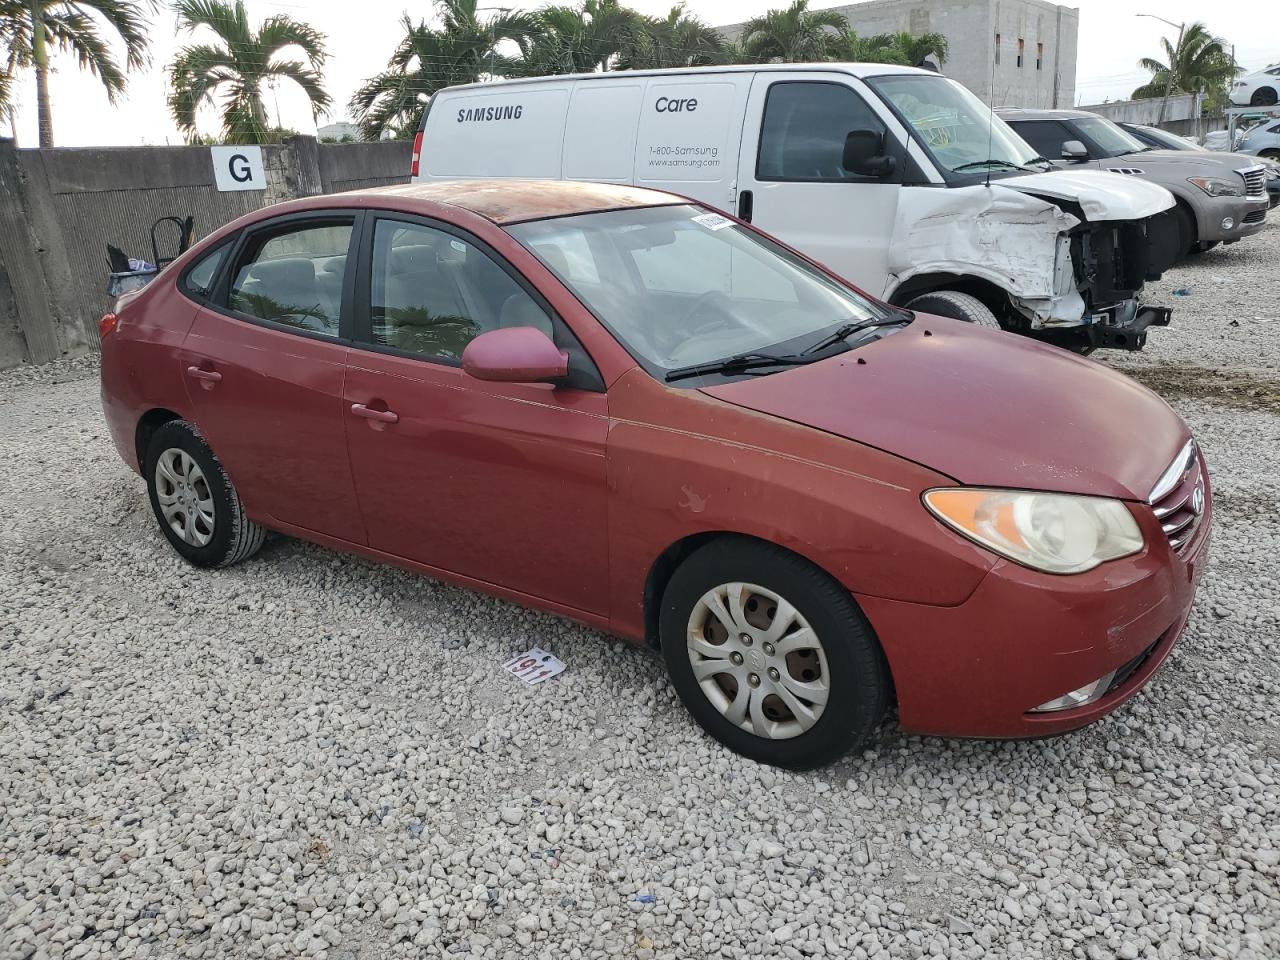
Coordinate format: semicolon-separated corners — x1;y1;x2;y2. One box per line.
659;536;892;769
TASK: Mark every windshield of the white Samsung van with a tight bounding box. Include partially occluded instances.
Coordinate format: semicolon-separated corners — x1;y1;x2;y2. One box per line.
867;76;1038;177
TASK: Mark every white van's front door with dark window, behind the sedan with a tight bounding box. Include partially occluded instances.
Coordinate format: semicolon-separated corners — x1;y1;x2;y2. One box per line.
735;72;905;296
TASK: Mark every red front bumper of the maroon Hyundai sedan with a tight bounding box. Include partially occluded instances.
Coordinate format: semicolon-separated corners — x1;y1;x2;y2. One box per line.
858;488;1212;737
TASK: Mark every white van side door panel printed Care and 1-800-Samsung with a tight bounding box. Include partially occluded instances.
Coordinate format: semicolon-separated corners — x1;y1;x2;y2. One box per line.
629;72;753;210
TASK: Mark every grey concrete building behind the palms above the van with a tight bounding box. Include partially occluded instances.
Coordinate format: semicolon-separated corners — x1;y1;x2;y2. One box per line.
719;0;1080;108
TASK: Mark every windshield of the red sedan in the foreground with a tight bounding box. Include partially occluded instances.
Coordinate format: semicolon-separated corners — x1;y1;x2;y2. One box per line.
507;204;888;378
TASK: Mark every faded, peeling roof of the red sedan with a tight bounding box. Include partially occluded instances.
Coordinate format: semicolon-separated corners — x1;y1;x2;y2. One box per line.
342;179;690;225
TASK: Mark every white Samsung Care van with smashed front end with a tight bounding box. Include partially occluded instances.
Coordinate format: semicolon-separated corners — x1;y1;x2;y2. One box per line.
412;63;1178;352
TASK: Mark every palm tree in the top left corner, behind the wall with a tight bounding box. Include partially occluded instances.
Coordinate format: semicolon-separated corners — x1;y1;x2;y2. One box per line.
0;0;154;147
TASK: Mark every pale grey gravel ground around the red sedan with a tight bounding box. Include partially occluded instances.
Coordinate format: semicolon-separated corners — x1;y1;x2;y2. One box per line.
0;227;1280;960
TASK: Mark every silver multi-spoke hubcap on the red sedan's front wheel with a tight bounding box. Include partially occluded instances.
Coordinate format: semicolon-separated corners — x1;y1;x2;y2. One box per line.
687;582;831;740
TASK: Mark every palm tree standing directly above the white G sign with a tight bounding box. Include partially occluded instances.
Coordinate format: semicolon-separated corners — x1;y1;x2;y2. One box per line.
169;0;330;143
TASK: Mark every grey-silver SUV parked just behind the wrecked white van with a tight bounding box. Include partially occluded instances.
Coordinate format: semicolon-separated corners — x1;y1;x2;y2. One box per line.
997;109;1270;253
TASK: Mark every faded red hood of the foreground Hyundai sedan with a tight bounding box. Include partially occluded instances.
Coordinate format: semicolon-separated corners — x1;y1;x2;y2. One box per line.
703;321;1190;500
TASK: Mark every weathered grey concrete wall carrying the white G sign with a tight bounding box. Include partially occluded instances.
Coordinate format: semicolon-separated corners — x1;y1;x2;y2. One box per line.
0;137;411;369
